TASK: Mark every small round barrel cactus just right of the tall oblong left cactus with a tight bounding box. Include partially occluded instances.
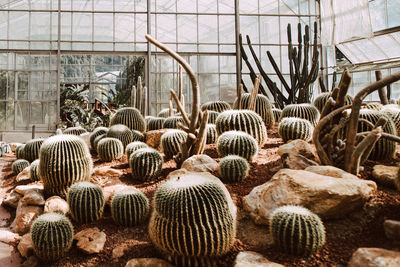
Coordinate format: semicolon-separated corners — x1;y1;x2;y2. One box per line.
97;137;124;162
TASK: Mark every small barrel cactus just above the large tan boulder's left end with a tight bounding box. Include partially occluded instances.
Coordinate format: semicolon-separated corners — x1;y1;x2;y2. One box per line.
219;155;250;183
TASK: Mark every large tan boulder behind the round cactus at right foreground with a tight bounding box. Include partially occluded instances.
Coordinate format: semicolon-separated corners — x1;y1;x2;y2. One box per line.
243;166;377;224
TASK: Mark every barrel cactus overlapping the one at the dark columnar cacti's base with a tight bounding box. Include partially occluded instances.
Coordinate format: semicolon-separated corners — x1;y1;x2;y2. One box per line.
278;117;314;142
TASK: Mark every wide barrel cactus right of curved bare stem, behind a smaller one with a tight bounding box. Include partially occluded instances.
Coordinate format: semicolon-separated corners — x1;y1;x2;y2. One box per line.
215;110;267;146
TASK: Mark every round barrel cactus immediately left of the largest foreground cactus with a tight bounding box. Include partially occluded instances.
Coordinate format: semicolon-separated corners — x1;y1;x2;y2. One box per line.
111;188;150;227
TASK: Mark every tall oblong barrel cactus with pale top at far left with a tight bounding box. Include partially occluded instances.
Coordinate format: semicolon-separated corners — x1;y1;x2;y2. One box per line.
39;135;93;196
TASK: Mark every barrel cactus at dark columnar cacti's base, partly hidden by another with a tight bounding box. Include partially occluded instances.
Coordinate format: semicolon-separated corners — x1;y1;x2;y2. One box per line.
280;103;320;127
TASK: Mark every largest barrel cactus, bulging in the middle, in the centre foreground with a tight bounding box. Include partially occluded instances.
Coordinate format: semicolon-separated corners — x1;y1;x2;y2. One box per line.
149;173;236;266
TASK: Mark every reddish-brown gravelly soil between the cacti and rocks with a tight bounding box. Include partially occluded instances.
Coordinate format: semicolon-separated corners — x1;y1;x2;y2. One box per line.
0;129;400;266
